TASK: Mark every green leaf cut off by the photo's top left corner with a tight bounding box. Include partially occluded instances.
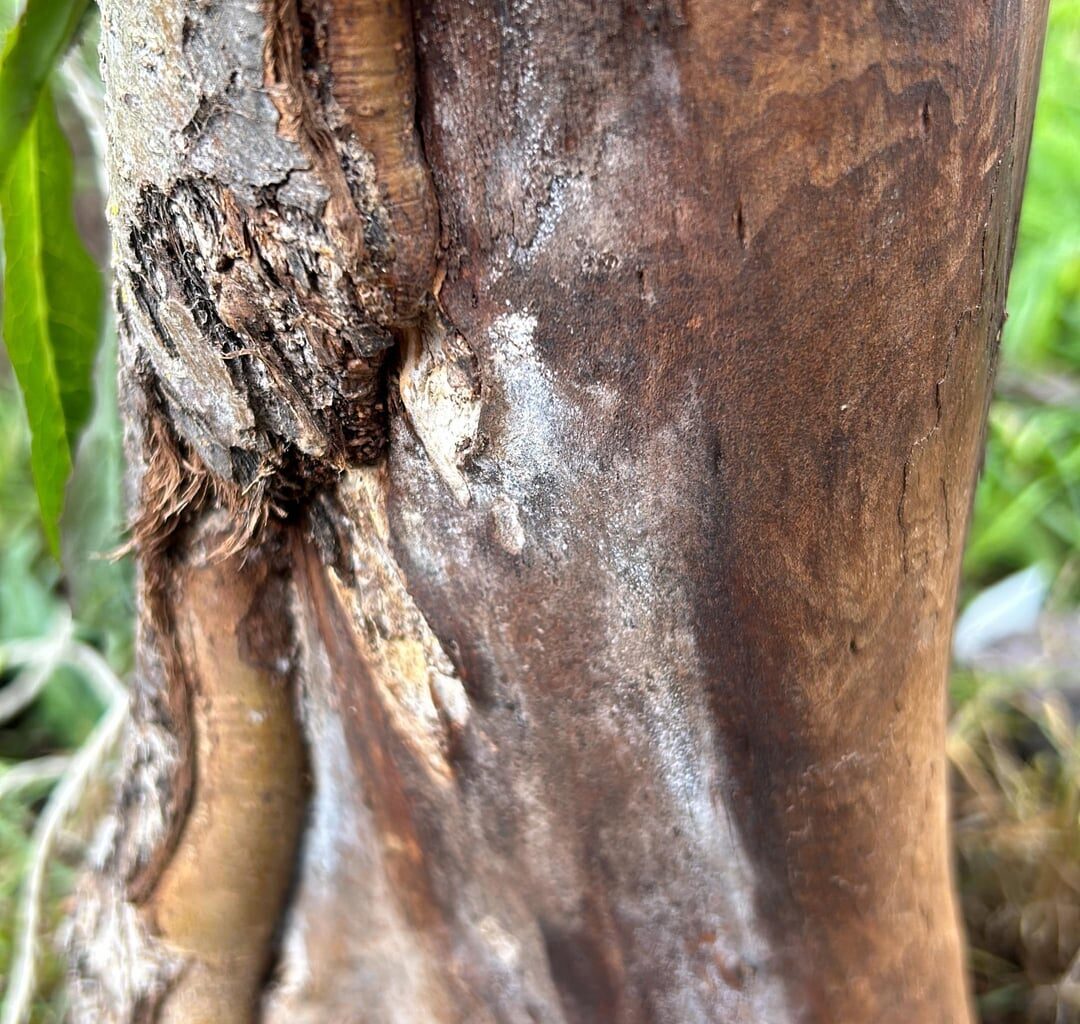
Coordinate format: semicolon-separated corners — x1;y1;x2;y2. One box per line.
0;0;90;178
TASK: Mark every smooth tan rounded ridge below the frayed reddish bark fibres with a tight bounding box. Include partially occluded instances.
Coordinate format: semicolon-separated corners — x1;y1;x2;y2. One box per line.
147;540;306;1024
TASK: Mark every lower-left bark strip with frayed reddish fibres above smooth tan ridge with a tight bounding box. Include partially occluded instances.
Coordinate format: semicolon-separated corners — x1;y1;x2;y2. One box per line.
71;409;308;1024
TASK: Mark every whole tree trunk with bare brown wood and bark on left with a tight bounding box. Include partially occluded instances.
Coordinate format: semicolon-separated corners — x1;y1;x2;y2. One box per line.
67;0;1045;1024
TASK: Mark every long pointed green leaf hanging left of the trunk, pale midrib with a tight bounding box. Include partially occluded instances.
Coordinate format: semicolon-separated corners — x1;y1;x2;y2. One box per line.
0;90;103;554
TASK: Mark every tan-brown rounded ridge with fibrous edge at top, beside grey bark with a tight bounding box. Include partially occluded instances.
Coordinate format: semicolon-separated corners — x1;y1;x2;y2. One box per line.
266;0;438;327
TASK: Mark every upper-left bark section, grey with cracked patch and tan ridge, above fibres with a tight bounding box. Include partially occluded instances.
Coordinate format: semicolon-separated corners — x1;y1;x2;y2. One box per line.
117;0;437;499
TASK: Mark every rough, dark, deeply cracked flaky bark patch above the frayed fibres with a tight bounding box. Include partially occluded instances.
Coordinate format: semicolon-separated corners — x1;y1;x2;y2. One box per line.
131;179;393;498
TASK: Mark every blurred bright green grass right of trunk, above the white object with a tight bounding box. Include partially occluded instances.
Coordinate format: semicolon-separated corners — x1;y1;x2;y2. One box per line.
964;0;1080;604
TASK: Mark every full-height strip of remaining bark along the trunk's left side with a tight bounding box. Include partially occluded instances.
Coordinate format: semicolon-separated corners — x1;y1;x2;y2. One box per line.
72;0;438;1024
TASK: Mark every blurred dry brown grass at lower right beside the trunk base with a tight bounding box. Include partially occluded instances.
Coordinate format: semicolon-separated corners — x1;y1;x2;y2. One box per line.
948;678;1080;1024
